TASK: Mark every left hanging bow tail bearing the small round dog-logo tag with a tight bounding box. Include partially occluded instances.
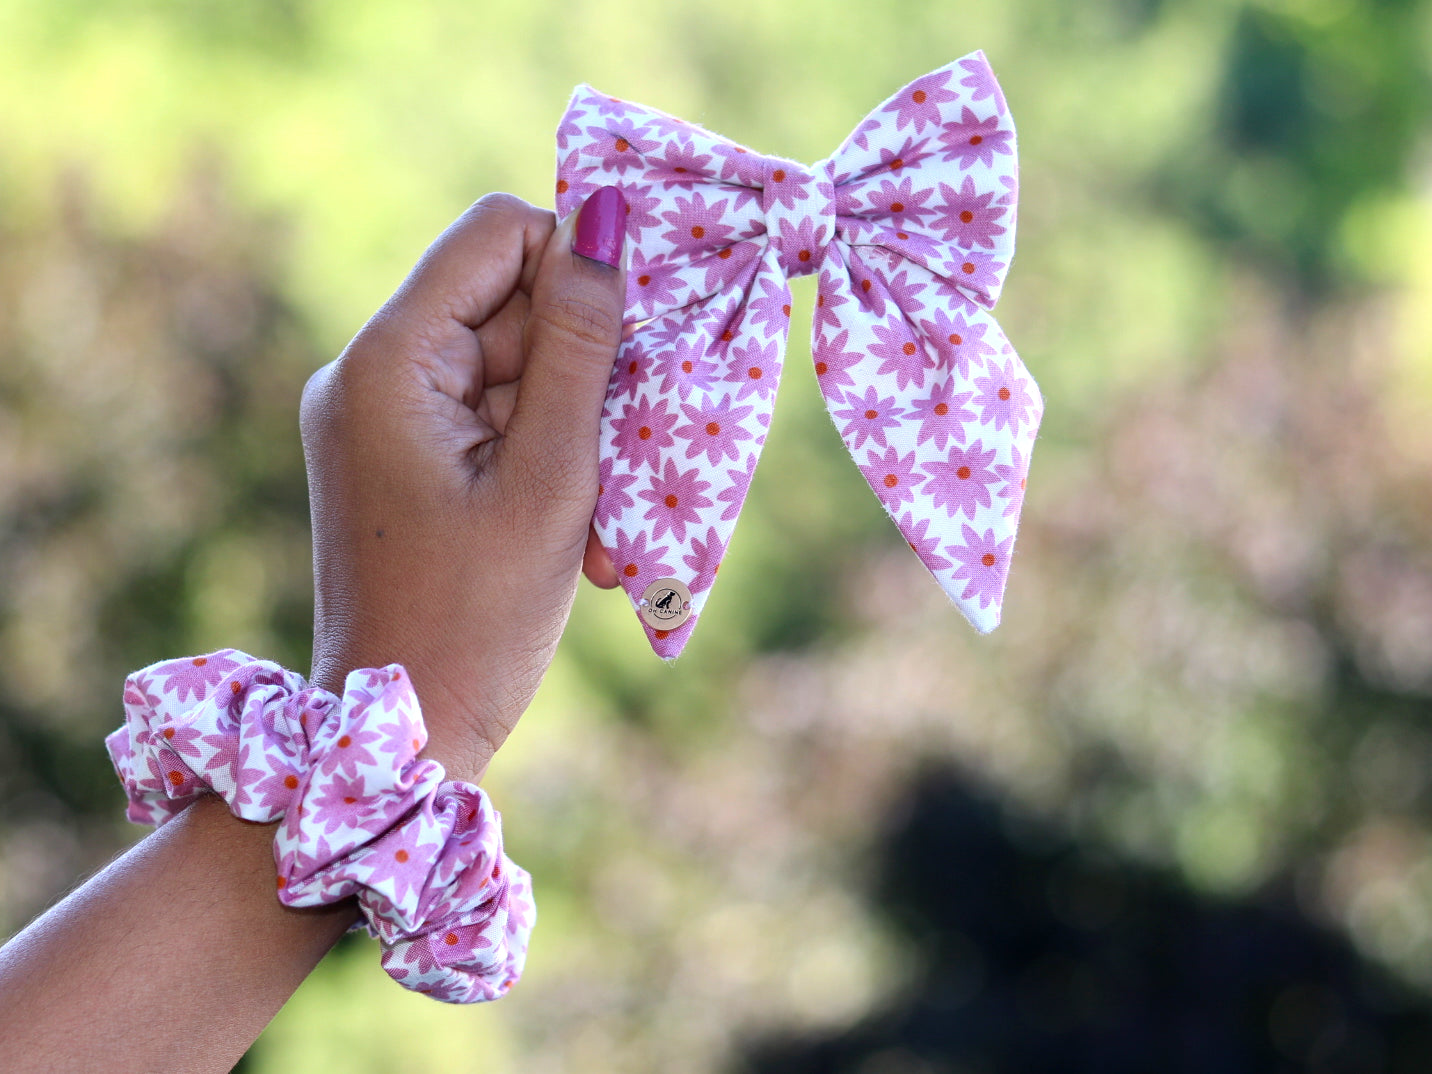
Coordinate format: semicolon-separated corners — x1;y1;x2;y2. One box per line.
593;251;790;660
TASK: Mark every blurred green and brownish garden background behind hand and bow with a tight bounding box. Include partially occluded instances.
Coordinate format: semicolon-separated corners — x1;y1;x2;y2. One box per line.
0;0;1432;1074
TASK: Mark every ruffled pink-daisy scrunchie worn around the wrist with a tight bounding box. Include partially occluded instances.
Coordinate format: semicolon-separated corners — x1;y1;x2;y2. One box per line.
105;649;536;1002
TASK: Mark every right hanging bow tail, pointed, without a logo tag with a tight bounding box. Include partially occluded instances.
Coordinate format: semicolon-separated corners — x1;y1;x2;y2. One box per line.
811;242;1044;633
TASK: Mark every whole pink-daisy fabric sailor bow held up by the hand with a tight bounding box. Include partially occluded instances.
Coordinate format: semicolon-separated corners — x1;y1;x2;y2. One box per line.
557;52;1044;659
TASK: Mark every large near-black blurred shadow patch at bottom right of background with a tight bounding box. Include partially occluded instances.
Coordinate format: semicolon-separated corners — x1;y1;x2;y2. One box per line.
736;769;1432;1074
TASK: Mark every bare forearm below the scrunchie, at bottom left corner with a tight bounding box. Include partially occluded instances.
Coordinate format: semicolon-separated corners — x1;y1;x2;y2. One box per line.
0;796;358;1071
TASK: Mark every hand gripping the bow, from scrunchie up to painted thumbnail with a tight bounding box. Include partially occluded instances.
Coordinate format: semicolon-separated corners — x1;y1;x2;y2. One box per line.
301;188;626;782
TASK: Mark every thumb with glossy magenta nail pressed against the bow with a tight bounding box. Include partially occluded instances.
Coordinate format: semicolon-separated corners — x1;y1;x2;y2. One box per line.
503;186;627;512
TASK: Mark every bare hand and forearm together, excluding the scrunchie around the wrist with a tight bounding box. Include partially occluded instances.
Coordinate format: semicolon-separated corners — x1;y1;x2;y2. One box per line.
0;188;626;1070
